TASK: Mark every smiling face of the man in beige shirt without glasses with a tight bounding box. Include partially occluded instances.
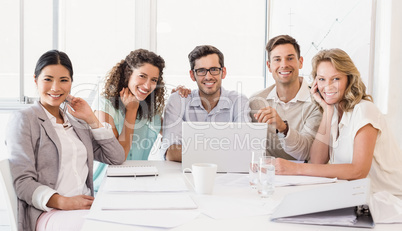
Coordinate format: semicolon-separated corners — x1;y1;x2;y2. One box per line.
267;43;303;85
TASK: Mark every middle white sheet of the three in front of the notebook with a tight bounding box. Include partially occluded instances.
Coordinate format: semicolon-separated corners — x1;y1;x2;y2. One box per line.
99;193;197;210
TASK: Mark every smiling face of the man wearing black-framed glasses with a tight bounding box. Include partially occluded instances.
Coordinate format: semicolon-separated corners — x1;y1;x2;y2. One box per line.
190;54;226;98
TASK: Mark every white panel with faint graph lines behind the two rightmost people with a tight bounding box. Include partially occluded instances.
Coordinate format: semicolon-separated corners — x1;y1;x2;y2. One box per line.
268;0;372;86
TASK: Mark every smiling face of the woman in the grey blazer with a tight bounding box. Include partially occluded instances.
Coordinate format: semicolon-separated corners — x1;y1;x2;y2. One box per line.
35;64;72;114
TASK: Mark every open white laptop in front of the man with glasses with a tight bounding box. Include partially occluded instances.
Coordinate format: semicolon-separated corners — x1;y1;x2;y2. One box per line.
182;122;268;173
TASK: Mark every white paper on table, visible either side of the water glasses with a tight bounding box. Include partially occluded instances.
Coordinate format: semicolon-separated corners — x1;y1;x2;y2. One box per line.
215;173;337;187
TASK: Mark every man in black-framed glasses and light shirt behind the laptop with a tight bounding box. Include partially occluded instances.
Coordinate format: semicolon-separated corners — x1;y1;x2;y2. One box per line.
160;45;251;162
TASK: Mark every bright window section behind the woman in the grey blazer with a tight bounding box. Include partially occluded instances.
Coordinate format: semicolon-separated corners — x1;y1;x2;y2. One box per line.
0;0;136;106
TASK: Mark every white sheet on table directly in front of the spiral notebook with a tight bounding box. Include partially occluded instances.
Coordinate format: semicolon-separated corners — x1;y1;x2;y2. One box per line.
103;176;188;192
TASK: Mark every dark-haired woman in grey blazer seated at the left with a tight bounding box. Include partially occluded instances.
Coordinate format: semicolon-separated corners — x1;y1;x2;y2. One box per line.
6;50;124;230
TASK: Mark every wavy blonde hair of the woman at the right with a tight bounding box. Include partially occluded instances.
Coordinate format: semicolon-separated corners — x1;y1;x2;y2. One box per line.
311;48;373;112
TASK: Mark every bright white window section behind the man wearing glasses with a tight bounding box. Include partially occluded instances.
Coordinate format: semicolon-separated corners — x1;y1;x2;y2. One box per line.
157;0;266;96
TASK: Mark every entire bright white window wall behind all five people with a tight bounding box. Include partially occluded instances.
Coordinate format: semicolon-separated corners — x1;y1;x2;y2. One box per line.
0;0;374;158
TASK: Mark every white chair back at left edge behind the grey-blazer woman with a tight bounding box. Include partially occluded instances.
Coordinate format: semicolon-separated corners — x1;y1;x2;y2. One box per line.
0;159;18;231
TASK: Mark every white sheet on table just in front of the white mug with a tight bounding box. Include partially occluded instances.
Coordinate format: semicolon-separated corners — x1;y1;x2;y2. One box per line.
194;195;280;219
